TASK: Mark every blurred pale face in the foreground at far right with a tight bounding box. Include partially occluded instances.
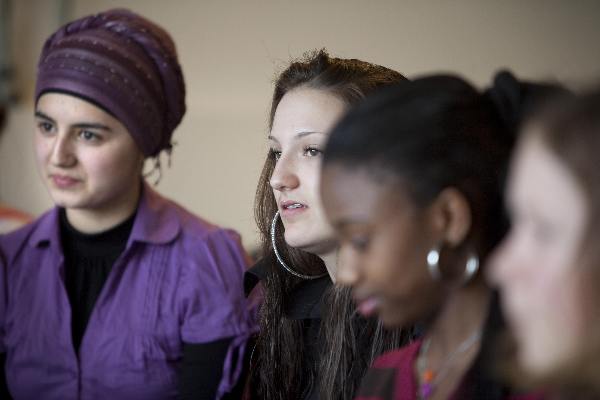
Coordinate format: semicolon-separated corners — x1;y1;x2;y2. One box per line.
489;133;600;376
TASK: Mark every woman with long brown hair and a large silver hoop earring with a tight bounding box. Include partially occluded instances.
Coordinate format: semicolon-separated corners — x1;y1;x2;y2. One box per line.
247;50;406;399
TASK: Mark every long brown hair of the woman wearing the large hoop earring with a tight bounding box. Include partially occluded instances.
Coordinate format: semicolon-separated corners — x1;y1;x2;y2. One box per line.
250;50;407;400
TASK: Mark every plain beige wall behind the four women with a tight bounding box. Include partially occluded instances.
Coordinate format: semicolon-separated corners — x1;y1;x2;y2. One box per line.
0;0;600;247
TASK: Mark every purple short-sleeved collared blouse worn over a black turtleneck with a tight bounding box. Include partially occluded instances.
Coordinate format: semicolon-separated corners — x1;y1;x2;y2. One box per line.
0;185;255;400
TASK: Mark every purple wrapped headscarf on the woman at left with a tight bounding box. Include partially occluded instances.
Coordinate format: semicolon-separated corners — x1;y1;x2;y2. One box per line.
35;9;185;156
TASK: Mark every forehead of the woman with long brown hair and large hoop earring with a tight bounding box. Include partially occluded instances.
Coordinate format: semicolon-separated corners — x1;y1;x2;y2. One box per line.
271;87;347;141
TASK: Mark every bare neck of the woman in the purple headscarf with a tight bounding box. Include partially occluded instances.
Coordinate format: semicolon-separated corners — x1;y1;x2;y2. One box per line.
66;180;141;233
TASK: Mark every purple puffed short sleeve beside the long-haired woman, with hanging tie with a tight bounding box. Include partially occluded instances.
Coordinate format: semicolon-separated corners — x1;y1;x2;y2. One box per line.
178;230;257;399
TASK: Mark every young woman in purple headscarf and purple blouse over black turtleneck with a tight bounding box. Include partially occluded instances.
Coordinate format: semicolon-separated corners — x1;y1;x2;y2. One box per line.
0;10;253;400
